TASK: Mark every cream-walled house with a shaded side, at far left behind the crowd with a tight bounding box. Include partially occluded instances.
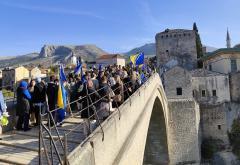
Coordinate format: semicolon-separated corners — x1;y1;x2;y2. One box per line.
2;66;29;87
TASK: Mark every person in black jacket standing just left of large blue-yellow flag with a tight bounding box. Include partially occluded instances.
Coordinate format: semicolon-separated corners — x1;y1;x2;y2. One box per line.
47;75;58;125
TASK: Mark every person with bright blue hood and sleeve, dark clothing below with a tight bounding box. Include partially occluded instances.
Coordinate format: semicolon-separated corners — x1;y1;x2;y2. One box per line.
16;81;32;131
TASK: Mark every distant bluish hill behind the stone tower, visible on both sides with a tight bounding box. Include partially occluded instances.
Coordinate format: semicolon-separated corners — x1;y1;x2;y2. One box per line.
124;43;217;56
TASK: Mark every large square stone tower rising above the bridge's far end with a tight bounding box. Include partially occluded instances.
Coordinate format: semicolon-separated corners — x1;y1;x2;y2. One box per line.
155;29;197;70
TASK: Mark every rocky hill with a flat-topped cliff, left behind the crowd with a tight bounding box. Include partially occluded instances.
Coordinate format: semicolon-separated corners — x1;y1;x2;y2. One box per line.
0;45;106;68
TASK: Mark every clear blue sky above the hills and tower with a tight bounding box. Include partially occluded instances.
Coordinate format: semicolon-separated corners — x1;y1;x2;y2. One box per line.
0;0;240;56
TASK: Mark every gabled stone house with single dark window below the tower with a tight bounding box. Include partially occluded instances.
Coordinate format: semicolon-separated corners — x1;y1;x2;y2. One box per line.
163;66;192;99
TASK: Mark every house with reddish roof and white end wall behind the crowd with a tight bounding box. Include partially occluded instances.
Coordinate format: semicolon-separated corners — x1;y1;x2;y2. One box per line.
96;54;125;66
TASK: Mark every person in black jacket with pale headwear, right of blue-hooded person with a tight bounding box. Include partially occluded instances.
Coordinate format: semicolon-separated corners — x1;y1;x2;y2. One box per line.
33;78;46;125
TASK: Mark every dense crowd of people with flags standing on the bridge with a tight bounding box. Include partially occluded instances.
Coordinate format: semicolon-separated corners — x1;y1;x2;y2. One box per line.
16;65;154;131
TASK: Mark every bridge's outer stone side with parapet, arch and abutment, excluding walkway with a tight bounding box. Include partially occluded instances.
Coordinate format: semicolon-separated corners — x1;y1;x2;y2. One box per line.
68;74;200;165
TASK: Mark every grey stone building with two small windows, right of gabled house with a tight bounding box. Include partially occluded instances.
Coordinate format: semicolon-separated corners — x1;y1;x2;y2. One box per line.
191;69;230;104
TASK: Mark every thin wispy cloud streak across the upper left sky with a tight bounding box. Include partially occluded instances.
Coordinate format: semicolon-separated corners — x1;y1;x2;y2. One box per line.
1;2;104;19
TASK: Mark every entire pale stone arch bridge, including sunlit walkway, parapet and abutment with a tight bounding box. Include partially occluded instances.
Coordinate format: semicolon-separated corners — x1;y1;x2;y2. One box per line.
0;74;200;165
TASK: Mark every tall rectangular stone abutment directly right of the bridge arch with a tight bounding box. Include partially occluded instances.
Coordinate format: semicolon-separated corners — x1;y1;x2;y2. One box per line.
168;99;201;164
